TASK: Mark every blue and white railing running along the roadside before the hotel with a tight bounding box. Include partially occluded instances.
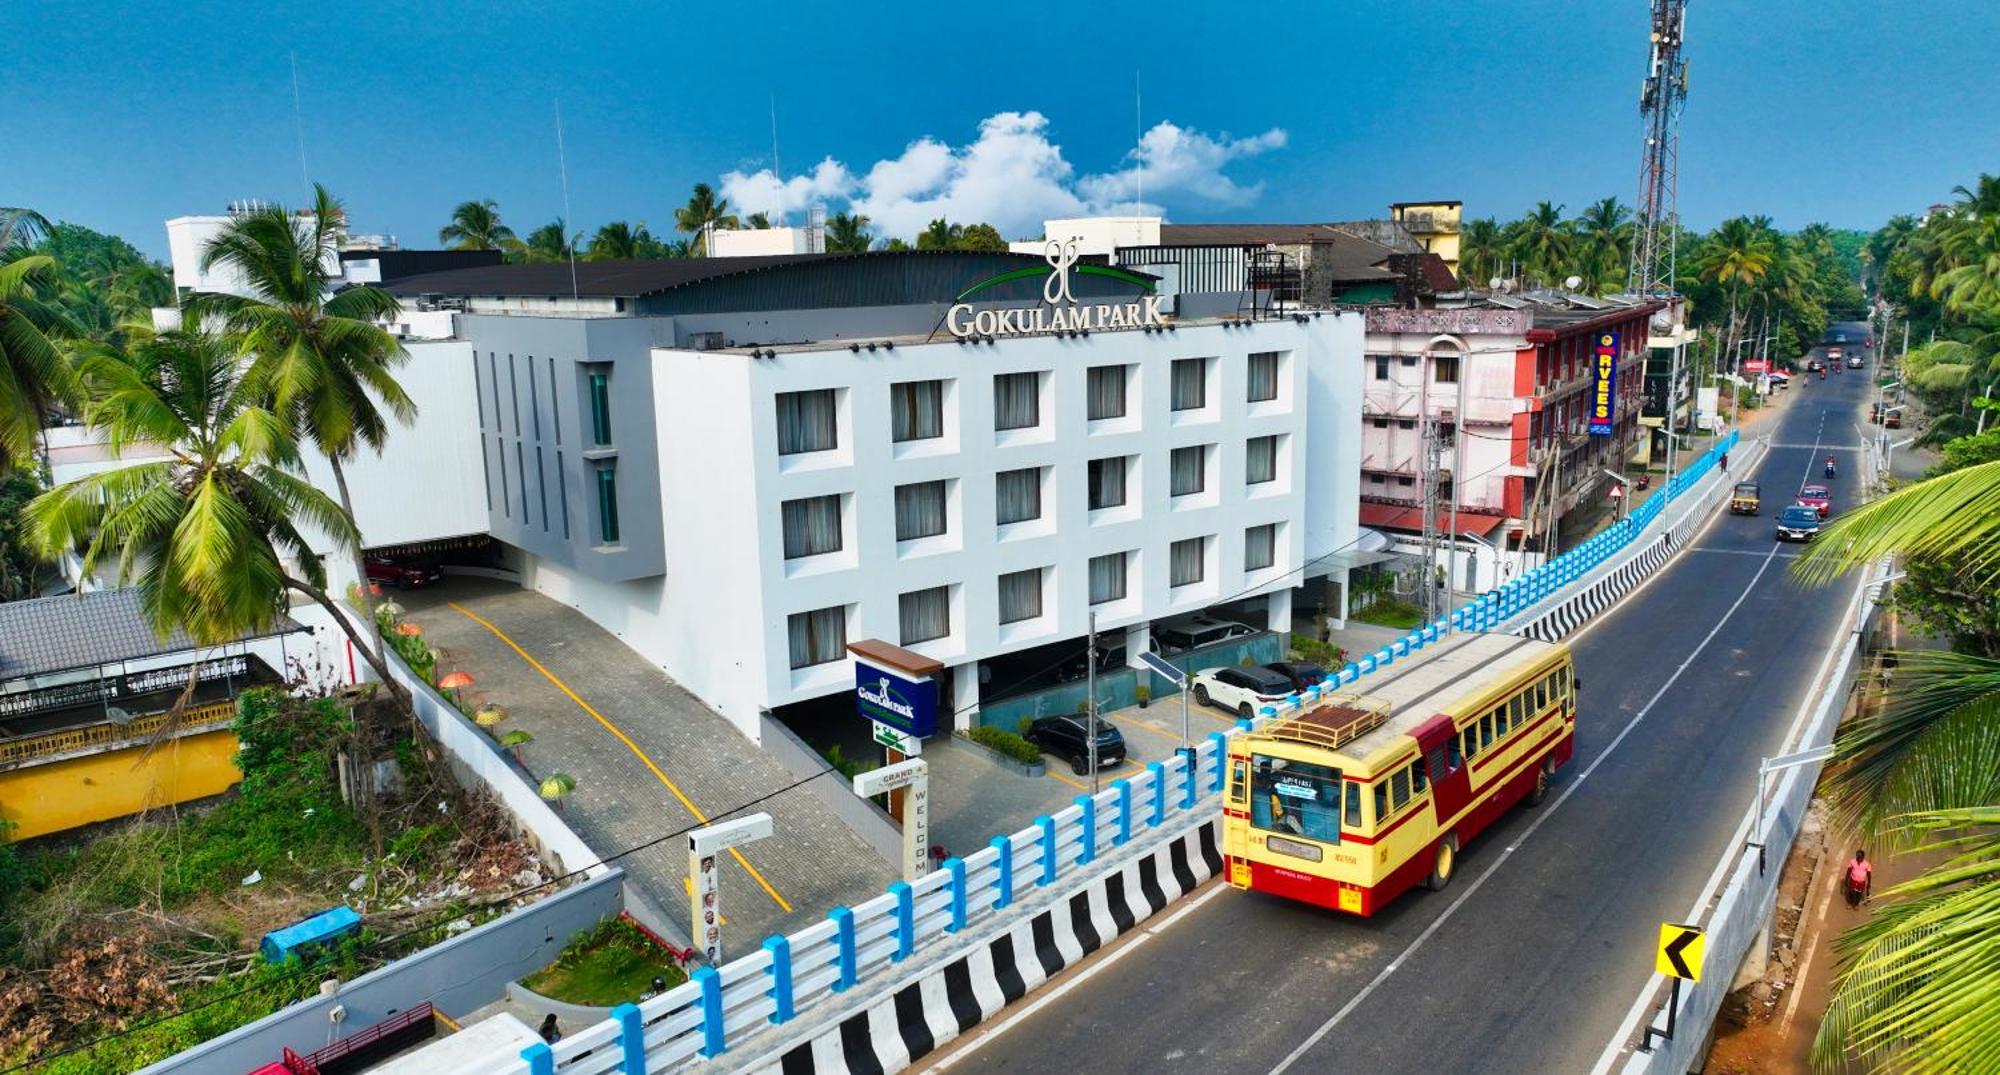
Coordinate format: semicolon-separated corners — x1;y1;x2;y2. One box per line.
494;432;1738;1075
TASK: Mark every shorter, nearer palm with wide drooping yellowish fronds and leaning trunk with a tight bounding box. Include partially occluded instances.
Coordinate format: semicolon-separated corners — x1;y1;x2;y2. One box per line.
28;320;406;683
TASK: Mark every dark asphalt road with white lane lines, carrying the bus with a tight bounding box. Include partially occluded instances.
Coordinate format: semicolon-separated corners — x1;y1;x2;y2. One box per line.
936;324;1874;1073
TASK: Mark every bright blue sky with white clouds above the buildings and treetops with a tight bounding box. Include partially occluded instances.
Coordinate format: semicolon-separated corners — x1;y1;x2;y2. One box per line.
0;0;2000;254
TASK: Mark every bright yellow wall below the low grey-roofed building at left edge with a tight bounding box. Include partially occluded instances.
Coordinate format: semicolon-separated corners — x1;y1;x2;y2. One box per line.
0;729;242;839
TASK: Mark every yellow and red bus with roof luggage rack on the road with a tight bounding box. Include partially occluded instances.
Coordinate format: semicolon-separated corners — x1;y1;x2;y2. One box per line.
1222;633;1580;917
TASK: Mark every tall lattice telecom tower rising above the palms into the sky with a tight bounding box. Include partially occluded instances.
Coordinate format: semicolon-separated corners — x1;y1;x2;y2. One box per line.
1626;0;1688;296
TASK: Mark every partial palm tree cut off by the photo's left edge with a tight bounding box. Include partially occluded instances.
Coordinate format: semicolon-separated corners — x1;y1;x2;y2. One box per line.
0;250;76;474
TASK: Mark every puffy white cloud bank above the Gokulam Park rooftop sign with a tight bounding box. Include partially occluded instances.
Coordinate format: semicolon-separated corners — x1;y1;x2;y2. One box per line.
722;112;1286;238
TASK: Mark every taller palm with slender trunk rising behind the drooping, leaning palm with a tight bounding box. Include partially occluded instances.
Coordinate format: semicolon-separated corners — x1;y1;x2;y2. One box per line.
184;184;416;671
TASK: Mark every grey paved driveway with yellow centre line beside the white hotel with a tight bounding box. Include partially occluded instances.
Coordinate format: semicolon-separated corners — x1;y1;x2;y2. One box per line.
396;577;894;953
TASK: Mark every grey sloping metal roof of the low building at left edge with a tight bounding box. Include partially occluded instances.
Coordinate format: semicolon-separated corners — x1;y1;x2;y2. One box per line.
0;587;306;681
